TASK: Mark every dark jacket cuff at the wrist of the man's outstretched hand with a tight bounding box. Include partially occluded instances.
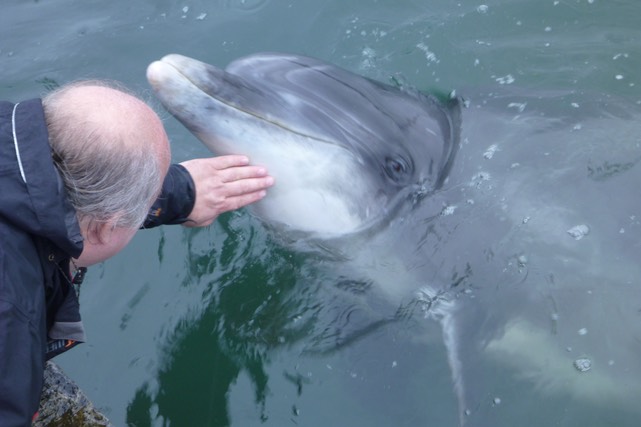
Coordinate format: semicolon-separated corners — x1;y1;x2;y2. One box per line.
142;164;196;228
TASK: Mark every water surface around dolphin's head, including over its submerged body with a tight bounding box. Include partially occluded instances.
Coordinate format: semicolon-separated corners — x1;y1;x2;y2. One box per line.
0;0;641;426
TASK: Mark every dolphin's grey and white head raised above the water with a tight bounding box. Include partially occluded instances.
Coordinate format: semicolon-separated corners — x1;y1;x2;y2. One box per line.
147;53;460;236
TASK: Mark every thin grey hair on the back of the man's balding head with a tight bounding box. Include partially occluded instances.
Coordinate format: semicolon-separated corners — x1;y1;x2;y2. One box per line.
42;80;164;232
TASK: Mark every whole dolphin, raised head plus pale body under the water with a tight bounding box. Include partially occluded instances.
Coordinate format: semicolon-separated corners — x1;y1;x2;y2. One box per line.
147;54;641;425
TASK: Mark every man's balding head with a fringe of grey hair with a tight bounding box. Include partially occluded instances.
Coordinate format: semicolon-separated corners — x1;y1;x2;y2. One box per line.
43;81;170;265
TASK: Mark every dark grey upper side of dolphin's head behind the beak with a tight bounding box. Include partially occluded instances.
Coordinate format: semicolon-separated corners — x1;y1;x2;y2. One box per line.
225;53;461;189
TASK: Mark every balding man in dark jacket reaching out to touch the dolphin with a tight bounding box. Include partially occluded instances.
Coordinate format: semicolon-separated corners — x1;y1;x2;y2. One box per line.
0;82;273;427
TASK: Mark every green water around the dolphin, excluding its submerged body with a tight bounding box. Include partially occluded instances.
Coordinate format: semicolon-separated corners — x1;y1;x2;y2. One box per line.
0;0;641;426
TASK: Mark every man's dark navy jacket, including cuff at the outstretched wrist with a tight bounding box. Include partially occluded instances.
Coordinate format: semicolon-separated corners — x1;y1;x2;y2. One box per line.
0;99;195;427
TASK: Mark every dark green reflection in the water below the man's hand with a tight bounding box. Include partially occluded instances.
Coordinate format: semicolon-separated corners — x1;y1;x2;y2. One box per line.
127;219;322;426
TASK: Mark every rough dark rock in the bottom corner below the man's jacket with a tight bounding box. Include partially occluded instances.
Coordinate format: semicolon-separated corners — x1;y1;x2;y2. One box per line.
32;362;112;427
